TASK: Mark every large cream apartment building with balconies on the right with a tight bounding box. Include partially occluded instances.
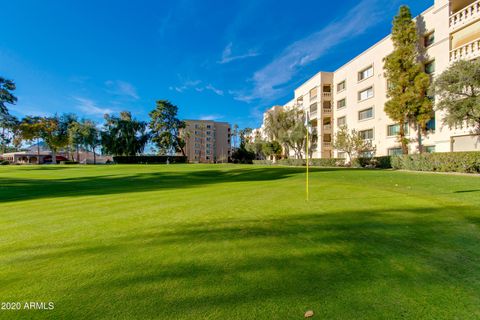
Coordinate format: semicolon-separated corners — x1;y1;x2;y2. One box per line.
258;0;480;158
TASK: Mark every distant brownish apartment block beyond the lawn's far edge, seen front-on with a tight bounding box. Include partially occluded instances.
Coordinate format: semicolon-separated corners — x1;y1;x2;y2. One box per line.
184;120;231;163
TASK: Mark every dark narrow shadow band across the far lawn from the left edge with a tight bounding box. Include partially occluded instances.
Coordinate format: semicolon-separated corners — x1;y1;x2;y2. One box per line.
0;167;345;203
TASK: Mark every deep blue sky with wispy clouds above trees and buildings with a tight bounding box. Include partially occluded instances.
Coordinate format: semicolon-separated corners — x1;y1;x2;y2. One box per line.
0;0;433;127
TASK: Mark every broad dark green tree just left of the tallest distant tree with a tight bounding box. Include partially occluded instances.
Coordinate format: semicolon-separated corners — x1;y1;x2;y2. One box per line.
101;111;150;156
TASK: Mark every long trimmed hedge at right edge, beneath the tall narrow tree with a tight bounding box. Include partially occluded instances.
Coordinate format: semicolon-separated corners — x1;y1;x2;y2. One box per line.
392;152;480;173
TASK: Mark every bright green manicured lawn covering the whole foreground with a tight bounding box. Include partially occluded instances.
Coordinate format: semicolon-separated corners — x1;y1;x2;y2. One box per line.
0;165;480;319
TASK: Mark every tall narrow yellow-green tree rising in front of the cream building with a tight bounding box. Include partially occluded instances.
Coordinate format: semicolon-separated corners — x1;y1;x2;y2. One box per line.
384;6;433;154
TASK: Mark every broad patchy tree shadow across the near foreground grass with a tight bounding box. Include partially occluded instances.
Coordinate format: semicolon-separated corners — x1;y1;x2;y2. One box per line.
8;206;480;319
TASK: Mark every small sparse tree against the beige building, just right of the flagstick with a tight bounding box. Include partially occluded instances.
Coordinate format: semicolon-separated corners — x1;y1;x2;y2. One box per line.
332;126;376;164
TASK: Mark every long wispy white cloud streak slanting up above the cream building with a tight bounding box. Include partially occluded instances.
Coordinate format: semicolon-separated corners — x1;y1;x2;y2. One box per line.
238;0;383;102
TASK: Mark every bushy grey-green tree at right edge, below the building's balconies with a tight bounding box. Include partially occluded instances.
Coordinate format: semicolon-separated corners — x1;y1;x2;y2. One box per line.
434;60;480;134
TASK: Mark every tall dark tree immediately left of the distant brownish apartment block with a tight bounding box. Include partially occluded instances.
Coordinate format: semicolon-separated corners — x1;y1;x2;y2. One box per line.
149;100;185;156
